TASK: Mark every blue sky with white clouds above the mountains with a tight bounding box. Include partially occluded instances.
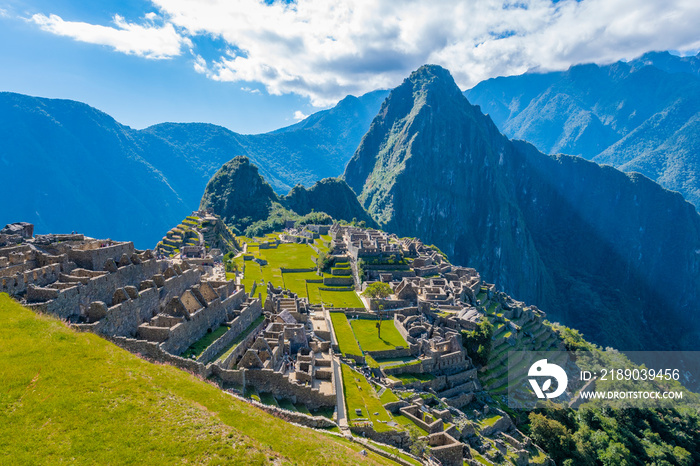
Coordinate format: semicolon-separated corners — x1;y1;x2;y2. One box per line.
0;0;700;133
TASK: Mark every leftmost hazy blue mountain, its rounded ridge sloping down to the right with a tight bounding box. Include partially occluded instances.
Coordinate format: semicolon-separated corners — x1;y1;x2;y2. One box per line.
0;93;191;247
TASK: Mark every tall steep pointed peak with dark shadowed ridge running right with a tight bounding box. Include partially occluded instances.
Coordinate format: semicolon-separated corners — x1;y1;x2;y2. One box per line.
343;66;700;350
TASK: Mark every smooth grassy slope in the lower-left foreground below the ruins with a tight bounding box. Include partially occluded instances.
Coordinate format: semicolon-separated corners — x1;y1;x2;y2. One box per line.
0;294;387;464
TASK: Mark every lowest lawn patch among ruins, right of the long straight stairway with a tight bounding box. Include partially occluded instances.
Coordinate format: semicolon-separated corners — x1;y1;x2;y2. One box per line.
341;364;393;432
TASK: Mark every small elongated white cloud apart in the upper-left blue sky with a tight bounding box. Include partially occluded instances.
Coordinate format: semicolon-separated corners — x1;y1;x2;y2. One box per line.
31;14;192;59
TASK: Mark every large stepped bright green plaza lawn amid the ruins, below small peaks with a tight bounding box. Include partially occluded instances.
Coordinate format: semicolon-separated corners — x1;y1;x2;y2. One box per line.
234;234;363;307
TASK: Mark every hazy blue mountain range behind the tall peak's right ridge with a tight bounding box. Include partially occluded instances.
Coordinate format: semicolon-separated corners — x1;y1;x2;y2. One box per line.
465;52;700;206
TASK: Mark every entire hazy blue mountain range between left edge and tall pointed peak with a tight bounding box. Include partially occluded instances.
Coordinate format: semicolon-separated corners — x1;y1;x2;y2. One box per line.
0;91;387;248
